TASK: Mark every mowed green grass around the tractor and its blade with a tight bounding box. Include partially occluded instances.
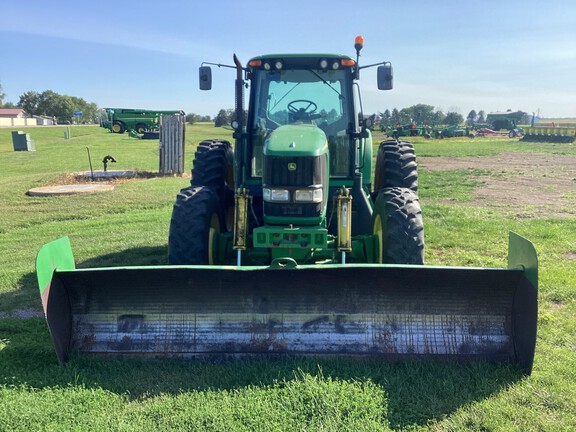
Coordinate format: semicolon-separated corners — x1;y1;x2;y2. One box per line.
0;124;576;431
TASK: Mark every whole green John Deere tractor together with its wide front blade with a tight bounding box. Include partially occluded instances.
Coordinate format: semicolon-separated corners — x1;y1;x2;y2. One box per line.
37;37;537;373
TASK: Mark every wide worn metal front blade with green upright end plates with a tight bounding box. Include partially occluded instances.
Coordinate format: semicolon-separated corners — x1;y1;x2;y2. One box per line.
37;233;538;373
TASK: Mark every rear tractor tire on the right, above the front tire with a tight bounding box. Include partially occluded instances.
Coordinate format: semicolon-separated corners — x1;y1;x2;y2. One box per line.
374;140;418;193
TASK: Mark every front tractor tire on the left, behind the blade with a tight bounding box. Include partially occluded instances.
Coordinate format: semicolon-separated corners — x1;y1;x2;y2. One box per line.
168;187;222;265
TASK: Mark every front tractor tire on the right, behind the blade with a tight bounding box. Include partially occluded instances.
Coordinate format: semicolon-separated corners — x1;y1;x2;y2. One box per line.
372;187;424;264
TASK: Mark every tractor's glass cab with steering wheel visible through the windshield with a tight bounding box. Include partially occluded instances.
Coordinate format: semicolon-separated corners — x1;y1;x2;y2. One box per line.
247;55;361;178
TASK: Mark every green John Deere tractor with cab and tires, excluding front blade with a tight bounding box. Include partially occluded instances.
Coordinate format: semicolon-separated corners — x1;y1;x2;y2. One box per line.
169;39;424;265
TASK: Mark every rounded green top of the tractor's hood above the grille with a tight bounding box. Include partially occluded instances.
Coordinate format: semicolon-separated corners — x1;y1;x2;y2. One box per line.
264;123;328;157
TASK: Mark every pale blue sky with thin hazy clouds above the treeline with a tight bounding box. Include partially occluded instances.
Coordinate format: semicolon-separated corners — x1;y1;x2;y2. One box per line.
0;0;576;118
